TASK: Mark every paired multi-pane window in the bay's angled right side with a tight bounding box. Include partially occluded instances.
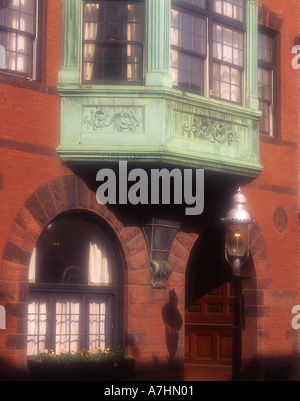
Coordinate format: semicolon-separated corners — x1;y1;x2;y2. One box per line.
171;0;246;104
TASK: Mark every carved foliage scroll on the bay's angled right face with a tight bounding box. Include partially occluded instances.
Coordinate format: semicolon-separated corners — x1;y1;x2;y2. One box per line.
183;118;239;146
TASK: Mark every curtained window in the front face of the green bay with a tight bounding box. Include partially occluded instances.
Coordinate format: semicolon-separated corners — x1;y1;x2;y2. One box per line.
83;0;144;84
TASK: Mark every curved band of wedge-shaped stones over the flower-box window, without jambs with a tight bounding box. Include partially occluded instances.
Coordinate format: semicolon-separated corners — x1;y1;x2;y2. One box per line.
2;174;150;294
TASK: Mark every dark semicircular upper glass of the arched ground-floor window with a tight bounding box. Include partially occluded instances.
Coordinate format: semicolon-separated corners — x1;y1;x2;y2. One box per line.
35;212;117;284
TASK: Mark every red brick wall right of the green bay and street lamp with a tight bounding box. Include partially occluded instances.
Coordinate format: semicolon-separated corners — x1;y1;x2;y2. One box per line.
244;0;300;363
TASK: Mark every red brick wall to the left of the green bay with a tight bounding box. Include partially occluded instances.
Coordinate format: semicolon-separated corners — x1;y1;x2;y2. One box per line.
0;0;66;369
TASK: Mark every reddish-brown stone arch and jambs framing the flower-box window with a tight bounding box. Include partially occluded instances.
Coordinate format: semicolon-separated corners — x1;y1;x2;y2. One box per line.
0;174;150;369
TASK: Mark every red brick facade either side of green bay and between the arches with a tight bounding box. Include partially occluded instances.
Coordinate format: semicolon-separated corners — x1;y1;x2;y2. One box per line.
0;0;300;378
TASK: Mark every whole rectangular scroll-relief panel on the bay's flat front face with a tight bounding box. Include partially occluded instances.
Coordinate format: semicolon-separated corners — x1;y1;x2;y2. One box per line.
82;107;143;132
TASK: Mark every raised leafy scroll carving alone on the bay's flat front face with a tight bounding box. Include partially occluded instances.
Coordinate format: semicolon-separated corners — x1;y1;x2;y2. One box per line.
83;107;142;132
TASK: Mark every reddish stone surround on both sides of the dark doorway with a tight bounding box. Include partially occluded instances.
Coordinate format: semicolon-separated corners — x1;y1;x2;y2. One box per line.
169;219;272;380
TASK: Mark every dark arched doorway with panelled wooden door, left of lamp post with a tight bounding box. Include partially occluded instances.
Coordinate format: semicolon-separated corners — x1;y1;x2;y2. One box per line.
185;223;233;380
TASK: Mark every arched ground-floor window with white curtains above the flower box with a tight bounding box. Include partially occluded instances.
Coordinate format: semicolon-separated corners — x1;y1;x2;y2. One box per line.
27;211;122;355
